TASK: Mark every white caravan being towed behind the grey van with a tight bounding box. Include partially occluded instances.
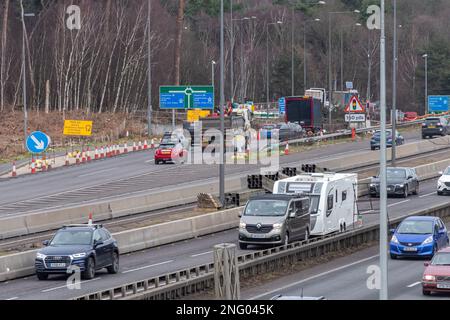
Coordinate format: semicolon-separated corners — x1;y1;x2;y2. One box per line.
273;173;358;236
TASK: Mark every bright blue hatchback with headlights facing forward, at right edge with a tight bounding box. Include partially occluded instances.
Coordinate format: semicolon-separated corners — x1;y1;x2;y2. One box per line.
390;217;449;259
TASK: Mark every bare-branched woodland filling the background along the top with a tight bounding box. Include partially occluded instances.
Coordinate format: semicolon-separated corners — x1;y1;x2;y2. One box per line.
0;0;450;113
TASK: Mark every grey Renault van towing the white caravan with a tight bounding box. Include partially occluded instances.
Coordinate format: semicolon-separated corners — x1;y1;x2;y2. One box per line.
239;194;310;249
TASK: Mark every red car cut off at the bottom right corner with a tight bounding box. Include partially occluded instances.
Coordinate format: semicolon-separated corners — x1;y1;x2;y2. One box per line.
422;247;450;296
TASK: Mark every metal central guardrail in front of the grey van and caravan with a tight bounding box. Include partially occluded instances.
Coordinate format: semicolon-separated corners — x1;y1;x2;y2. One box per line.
74;204;450;300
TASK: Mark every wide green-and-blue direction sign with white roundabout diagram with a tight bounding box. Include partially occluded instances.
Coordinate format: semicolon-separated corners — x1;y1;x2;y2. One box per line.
159;86;214;110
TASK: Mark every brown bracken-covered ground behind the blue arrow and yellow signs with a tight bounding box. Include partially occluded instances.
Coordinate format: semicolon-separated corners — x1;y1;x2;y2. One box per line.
0;111;146;162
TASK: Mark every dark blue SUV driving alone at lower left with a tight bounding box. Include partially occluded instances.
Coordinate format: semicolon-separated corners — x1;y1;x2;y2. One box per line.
35;224;119;280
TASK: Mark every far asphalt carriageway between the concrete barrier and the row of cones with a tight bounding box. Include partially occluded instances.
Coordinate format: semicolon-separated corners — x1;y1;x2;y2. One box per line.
0;131;421;217
